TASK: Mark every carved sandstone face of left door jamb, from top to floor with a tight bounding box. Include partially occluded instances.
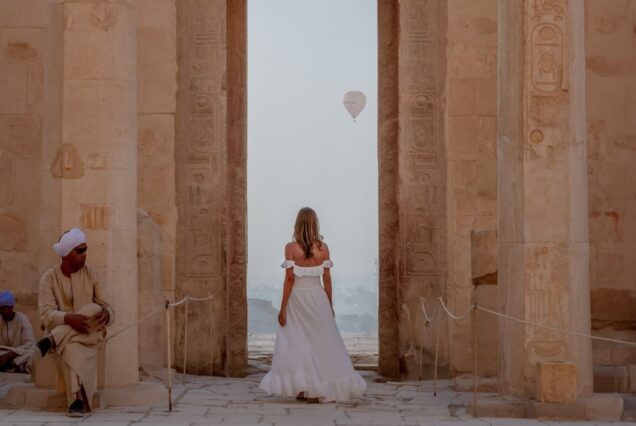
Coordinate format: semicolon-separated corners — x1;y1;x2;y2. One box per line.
176;0;227;374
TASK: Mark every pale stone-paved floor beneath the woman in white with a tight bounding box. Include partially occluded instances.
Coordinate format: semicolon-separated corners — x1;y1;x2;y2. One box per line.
0;371;636;426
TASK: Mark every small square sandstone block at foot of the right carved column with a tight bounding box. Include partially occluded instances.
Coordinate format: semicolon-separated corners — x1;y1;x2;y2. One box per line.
537;362;577;404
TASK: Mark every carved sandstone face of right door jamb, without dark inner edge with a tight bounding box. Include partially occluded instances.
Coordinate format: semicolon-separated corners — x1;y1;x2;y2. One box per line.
398;0;445;376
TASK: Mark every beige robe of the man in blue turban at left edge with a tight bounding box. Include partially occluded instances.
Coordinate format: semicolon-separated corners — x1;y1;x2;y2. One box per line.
0;312;35;372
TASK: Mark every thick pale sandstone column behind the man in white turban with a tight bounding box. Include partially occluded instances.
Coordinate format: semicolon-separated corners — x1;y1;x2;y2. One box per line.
38;0;139;403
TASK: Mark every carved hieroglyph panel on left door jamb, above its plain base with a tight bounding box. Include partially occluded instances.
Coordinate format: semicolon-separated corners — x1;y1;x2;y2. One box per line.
179;0;222;278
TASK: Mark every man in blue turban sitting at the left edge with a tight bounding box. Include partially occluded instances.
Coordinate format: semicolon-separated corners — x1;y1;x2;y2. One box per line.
0;291;35;373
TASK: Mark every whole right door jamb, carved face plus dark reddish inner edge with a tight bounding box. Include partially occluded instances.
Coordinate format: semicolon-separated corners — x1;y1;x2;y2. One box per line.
379;0;445;377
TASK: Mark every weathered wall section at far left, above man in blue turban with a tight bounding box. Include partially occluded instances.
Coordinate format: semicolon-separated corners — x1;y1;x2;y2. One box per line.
0;0;53;335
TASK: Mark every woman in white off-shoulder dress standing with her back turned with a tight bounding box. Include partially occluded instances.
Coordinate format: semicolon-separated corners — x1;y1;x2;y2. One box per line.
259;207;367;403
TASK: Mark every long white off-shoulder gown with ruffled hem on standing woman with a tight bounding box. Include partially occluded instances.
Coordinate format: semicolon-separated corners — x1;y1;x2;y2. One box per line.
259;260;367;402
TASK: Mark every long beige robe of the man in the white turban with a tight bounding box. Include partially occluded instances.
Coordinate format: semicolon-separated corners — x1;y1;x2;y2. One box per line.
39;266;115;405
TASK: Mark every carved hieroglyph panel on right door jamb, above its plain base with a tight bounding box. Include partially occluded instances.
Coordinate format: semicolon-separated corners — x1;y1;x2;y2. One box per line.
400;0;440;277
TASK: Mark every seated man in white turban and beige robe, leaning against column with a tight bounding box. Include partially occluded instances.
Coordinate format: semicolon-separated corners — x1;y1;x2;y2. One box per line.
37;228;114;417
